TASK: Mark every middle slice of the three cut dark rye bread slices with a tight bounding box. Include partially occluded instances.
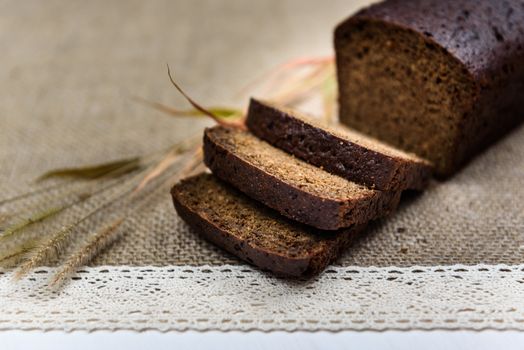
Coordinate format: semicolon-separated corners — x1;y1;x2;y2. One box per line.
204;126;400;230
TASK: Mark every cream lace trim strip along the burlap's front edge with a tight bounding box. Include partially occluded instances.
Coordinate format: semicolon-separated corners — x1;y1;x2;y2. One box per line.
0;265;524;331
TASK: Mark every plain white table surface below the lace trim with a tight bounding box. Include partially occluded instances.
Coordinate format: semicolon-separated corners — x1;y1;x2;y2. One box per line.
0;331;524;350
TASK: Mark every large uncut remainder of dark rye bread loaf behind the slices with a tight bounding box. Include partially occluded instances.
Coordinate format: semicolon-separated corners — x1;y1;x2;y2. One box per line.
335;0;524;176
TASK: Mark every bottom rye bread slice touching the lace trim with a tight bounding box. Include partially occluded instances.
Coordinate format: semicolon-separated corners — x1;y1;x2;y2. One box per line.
171;174;363;277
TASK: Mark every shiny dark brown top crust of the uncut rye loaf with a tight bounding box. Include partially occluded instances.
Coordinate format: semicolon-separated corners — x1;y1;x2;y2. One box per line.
340;0;524;77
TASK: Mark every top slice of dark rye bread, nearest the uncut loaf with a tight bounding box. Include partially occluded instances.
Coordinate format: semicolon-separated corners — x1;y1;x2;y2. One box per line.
246;99;431;191
